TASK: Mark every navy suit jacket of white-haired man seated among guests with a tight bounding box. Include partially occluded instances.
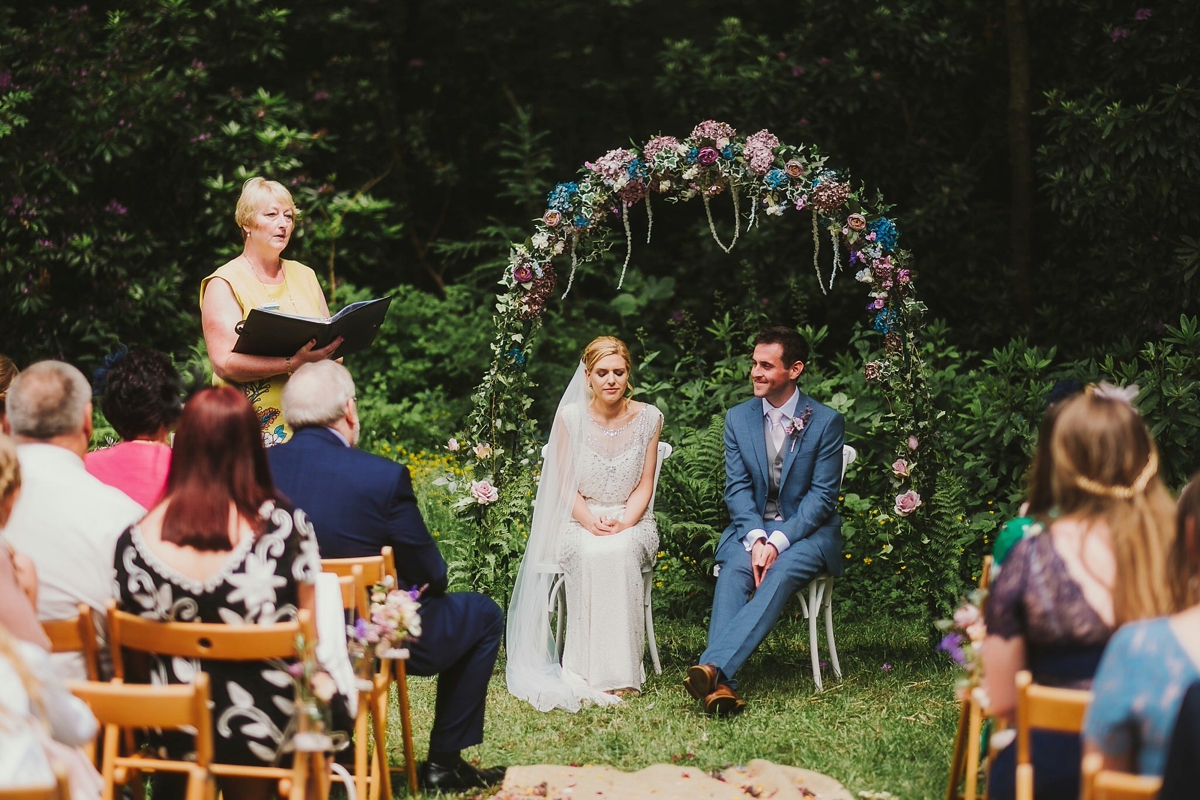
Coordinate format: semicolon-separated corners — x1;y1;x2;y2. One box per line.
266;427;446;595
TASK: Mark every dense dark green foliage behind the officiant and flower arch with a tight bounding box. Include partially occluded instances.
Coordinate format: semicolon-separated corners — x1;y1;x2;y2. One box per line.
0;0;1200;614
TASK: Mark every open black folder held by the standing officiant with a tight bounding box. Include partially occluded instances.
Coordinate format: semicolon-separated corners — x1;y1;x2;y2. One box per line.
233;295;391;357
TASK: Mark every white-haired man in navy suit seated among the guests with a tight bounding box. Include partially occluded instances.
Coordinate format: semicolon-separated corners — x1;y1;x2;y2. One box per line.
266;361;504;792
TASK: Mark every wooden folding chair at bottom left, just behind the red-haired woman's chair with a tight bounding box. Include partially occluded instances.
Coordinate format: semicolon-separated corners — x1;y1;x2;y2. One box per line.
70;673;216;800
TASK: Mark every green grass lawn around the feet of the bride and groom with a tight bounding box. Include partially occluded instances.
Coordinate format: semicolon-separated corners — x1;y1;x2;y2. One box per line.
389;603;959;799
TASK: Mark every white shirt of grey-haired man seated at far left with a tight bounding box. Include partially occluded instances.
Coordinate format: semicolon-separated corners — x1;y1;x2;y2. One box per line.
4;444;146;680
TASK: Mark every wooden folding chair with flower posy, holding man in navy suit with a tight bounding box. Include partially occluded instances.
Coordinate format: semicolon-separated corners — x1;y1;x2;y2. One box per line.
320;547;416;800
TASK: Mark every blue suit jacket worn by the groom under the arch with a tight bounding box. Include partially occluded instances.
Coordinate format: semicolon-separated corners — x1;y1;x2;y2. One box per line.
718;389;846;575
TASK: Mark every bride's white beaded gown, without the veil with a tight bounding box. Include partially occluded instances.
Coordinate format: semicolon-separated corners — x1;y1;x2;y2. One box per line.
558;404;662;691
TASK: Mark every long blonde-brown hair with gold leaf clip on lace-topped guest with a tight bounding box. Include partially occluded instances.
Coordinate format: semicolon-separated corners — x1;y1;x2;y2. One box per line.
1051;386;1175;625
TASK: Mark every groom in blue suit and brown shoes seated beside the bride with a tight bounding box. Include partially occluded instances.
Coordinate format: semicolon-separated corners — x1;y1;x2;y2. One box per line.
684;326;845;715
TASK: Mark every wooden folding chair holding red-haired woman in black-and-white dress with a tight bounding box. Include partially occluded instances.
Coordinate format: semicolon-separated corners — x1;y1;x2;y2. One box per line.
108;600;329;800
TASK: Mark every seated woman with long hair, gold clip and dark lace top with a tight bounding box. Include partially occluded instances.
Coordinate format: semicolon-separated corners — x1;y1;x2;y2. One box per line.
984;389;1175;800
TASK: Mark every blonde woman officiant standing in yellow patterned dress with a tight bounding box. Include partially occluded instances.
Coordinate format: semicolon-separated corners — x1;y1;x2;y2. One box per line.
200;178;342;447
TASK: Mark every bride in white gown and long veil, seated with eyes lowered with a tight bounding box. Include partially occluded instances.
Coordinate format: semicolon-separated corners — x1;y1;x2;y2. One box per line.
506;336;662;711
